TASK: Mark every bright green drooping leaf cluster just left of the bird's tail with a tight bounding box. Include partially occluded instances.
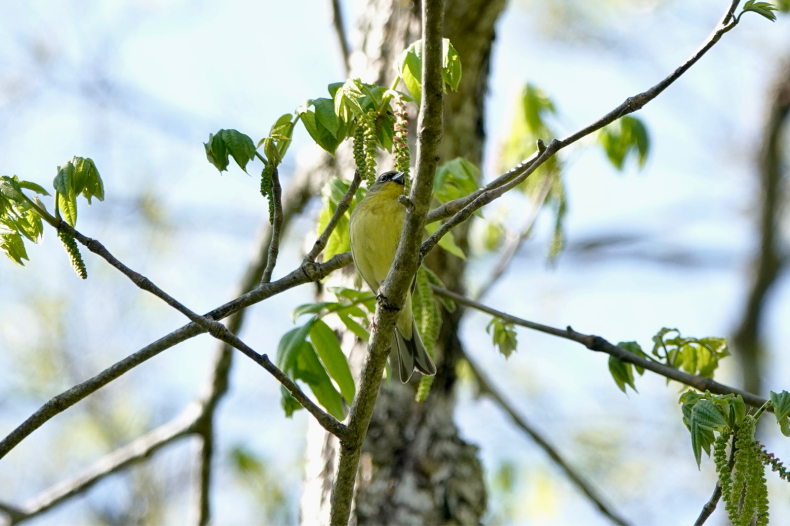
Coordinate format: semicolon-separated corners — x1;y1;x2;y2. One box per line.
277;288;376;420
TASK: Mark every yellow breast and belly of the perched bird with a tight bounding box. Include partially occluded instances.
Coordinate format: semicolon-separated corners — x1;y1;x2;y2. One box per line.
349;182;406;291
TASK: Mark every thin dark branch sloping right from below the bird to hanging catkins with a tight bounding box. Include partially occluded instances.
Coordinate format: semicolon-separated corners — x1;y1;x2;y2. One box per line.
431;285;770;410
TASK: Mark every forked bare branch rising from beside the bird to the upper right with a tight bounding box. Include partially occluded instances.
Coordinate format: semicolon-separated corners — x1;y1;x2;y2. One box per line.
422;2;737;237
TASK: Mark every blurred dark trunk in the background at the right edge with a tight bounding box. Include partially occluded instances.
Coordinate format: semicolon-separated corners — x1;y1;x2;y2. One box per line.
732;59;790;394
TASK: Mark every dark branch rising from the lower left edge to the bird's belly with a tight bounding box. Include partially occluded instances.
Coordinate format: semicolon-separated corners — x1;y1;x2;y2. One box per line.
0;252;352;458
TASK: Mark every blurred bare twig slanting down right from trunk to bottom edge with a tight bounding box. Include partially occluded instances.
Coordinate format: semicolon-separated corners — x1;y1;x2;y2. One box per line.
464;354;629;526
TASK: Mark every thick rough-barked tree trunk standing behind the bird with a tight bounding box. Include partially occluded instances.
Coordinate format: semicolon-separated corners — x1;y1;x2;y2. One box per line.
301;0;505;525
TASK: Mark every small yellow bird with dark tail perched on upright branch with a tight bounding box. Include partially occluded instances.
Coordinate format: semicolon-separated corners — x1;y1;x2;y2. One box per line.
349;171;436;384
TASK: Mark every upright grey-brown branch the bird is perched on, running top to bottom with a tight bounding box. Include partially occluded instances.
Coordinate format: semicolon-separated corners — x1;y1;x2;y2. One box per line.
330;0;444;526
